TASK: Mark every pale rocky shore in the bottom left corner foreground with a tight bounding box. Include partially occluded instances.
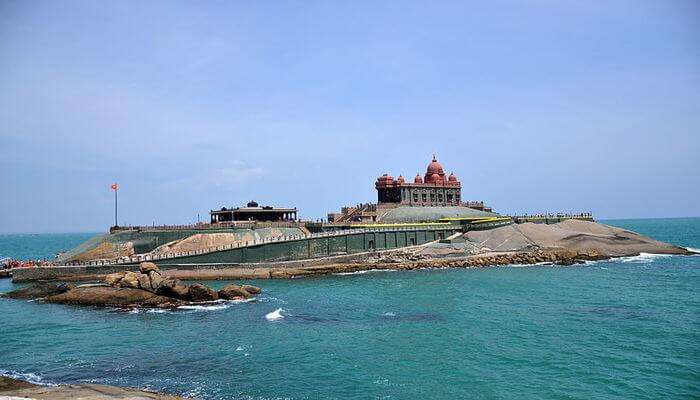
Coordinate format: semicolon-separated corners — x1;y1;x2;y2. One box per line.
0;375;187;400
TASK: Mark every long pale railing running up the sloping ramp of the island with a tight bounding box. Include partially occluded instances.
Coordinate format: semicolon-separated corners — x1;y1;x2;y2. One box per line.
63;223;454;266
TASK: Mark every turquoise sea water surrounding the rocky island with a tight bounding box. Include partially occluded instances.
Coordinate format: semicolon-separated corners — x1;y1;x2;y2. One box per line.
0;218;700;399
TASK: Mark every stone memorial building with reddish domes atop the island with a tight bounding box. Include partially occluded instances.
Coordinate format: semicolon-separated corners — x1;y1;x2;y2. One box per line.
374;156;462;206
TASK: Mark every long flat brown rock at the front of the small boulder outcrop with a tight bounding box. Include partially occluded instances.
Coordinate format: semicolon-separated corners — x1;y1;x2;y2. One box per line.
46;286;183;308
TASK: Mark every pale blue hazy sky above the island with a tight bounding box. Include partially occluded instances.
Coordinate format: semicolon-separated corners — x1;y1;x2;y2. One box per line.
0;0;700;232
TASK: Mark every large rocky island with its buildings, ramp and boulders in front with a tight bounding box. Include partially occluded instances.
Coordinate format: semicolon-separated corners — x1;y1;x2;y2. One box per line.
4;157;692;284
